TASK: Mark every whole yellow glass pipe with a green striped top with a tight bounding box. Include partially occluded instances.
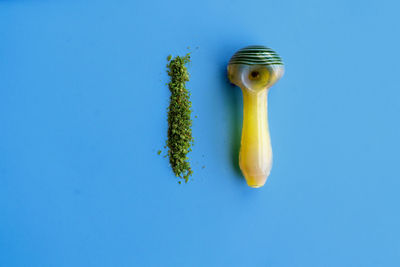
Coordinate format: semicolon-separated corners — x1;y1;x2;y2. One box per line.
228;46;284;188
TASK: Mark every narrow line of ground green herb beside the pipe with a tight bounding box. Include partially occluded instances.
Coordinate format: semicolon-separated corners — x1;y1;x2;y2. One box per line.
167;54;193;182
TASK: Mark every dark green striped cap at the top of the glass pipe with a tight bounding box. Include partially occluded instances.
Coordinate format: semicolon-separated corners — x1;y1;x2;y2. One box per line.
229;45;283;65
